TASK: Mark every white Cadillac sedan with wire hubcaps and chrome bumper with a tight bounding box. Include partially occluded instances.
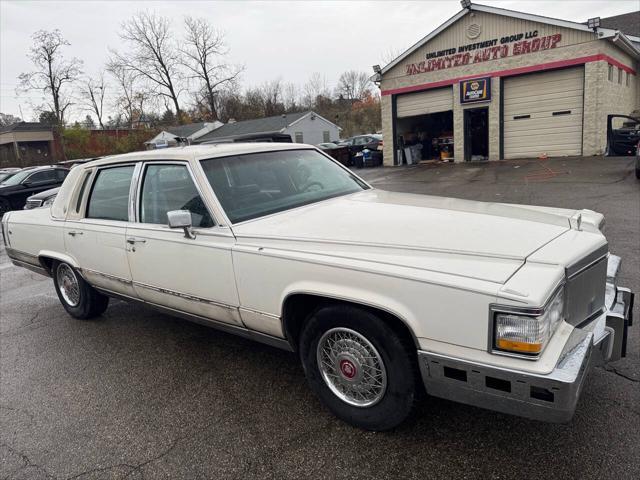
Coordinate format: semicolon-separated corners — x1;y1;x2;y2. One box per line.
2;143;633;430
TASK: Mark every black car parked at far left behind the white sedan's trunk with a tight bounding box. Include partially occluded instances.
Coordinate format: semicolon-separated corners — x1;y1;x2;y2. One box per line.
0;166;69;218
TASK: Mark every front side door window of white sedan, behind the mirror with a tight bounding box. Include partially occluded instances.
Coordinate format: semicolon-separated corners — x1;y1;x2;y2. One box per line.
140;165;213;228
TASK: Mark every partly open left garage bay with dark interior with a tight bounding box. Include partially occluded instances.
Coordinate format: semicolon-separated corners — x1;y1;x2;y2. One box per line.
395;87;454;164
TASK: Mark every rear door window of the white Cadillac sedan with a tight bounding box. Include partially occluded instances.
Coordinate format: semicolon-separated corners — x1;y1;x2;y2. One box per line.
87;165;133;222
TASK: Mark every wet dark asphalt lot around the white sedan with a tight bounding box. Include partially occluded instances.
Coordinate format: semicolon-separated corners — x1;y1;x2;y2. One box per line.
0;157;640;480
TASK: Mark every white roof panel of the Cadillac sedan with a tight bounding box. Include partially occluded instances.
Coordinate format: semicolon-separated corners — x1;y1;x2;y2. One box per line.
82;142;316;168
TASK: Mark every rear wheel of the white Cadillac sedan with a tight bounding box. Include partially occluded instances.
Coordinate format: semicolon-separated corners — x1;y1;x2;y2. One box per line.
51;262;109;320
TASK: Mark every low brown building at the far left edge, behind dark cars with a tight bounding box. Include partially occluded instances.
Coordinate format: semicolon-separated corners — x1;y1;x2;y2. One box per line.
0;122;56;168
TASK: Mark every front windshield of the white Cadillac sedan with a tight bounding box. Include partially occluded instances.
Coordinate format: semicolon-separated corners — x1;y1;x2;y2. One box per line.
202;150;369;223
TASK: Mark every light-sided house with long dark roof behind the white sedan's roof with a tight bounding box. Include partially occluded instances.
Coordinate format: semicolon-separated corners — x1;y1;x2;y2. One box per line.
192;111;342;145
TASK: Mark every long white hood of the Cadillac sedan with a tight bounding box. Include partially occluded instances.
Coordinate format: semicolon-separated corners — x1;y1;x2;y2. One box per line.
233;189;598;283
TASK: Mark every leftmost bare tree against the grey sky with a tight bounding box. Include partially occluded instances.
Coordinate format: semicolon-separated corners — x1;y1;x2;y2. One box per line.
18;29;82;125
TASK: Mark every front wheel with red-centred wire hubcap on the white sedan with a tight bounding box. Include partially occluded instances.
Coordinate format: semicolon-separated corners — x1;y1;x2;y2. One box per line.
300;305;419;431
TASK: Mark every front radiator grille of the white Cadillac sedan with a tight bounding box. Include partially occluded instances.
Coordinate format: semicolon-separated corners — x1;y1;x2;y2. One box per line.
565;246;608;325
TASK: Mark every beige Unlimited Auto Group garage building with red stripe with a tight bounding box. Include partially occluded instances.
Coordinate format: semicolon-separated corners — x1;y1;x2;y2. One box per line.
374;0;640;165
